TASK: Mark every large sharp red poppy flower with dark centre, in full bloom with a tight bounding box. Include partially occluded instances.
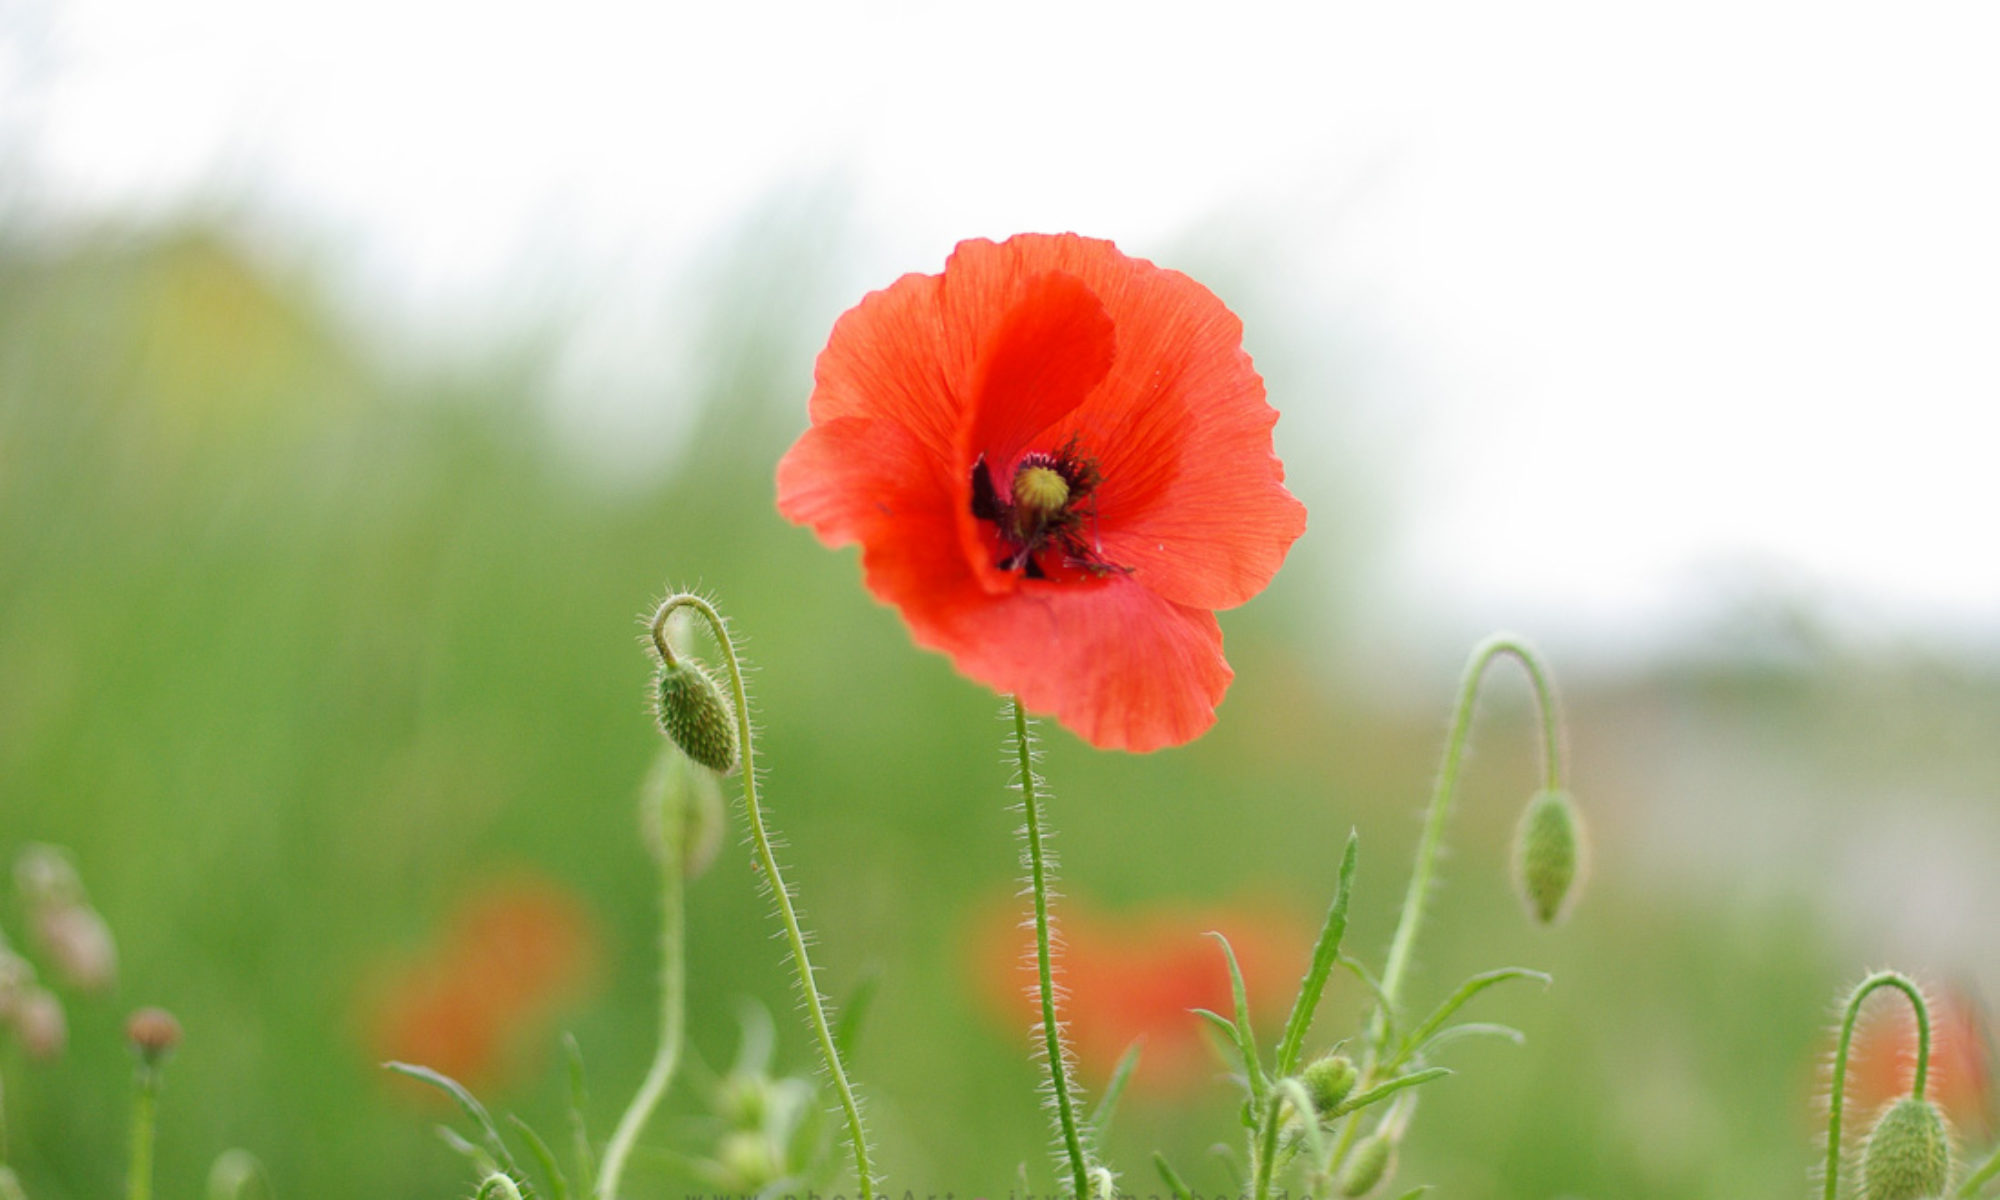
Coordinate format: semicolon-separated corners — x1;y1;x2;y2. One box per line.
778;234;1306;750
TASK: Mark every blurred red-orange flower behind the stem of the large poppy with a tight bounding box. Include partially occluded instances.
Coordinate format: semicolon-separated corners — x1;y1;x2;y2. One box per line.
974;900;1308;1094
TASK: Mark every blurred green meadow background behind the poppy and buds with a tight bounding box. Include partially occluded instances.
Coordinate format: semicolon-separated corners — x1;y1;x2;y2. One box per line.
0;216;2000;1200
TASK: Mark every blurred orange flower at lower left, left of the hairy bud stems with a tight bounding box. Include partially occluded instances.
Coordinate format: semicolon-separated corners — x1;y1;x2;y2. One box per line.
366;878;598;1088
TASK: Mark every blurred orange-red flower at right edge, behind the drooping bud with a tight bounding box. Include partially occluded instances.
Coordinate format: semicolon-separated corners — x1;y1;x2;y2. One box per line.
1848;988;2000;1144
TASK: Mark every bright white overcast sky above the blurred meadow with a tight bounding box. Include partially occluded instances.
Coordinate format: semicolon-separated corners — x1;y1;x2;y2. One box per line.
0;0;2000;644
